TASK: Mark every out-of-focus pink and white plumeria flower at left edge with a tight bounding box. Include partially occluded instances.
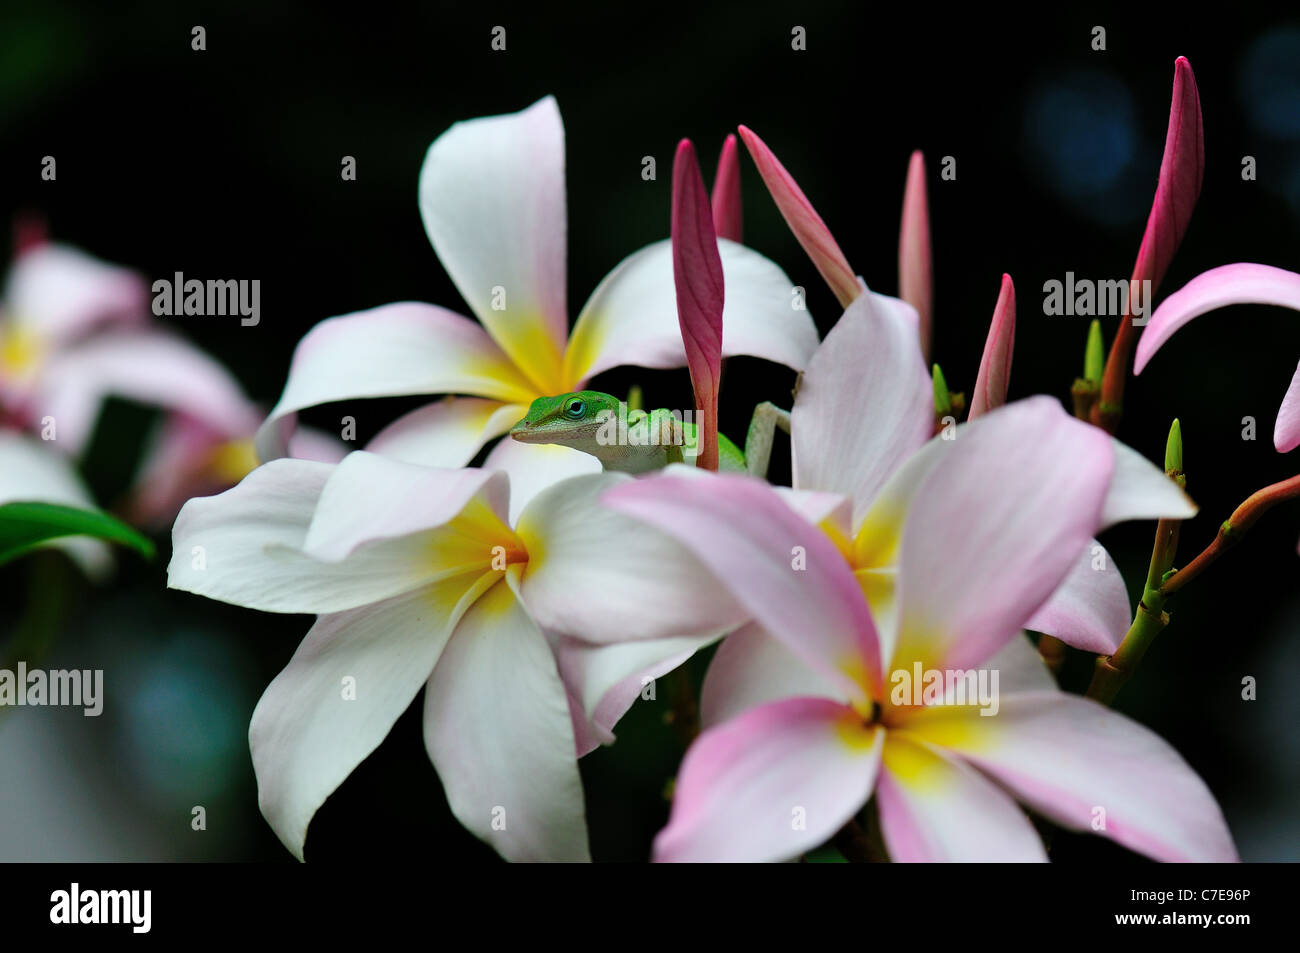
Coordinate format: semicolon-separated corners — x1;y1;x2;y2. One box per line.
0;234;345;525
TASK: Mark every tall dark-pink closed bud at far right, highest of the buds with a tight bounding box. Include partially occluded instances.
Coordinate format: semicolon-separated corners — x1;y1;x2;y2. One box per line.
1132;56;1205;291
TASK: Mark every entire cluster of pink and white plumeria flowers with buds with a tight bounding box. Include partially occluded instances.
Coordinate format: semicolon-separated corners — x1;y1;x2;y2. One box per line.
10;52;1300;861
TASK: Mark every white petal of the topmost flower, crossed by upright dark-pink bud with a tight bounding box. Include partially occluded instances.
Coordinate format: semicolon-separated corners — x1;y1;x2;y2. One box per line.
564;239;816;382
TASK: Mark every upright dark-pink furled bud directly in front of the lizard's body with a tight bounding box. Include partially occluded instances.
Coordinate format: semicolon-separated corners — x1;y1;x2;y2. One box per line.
672;139;724;469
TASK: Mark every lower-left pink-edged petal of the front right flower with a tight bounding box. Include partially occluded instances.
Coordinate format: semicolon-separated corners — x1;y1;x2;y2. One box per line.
654;698;884;862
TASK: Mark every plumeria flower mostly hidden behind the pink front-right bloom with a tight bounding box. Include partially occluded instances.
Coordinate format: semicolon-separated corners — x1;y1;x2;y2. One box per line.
571;294;1196;722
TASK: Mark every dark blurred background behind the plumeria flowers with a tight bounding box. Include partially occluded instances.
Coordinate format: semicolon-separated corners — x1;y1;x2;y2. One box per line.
0;0;1300;862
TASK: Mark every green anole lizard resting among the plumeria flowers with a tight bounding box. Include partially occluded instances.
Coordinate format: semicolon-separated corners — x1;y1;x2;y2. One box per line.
510;390;790;476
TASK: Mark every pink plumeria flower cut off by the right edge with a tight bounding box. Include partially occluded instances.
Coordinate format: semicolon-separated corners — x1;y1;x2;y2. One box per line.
1134;261;1300;454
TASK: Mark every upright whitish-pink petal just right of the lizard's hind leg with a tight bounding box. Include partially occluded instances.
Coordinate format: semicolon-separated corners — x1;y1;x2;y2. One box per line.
790;295;935;528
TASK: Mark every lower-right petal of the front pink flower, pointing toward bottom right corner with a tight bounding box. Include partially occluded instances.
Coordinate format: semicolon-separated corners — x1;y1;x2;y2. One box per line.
907;692;1238;862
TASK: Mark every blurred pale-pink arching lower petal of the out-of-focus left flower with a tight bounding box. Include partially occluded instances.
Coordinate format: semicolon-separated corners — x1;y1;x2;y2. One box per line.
36;330;261;455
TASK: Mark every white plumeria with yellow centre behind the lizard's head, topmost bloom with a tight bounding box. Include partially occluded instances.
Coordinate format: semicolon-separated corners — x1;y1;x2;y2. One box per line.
257;96;816;509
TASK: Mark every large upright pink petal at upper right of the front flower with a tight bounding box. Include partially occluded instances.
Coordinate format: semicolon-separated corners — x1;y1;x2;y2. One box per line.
893;397;1114;668
